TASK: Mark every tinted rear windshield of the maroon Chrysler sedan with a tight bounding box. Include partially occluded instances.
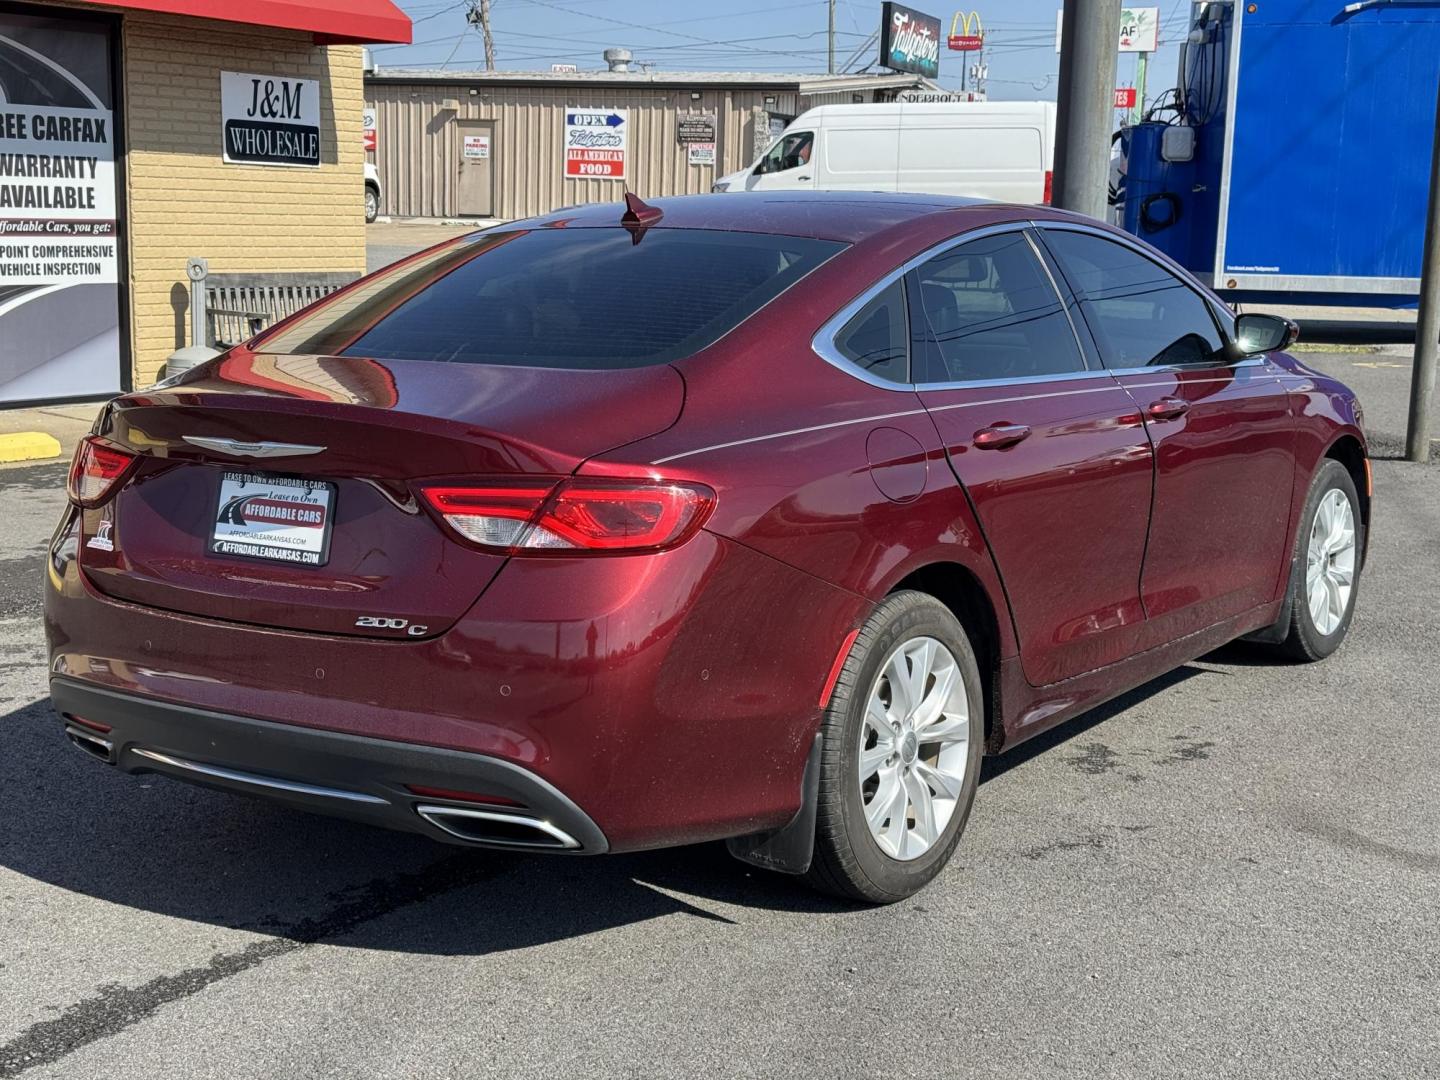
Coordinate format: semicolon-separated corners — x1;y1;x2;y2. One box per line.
255;228;845;369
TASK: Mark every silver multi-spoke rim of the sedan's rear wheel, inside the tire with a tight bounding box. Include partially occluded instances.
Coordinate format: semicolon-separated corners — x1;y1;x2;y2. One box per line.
857;636;971;861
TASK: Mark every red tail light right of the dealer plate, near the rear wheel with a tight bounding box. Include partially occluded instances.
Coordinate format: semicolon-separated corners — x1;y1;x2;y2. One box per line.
420;477;716;554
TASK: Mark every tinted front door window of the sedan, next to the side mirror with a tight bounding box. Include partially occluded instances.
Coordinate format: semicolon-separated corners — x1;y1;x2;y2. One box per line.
1044;229;1224;369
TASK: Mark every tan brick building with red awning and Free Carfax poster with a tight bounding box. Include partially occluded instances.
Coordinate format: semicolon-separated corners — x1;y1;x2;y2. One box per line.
0;0;410;406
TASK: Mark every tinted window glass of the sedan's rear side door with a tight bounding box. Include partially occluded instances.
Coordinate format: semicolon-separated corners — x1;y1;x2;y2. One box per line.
913;232;1084;383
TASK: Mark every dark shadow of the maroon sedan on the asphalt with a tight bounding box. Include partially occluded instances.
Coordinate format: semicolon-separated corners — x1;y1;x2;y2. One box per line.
0;665;1226;955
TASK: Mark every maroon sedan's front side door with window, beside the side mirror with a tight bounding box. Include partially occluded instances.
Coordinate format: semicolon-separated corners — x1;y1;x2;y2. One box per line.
1041;225;1295;645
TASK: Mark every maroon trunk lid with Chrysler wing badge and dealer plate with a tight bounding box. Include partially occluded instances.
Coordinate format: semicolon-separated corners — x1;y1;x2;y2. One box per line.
81;350;684;639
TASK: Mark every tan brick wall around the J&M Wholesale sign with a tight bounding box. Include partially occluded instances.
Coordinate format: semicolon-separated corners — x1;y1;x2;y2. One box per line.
122;13;364;386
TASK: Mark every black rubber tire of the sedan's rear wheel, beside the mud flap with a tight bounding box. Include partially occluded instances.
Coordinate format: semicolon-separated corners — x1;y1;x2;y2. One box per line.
805;592;985;904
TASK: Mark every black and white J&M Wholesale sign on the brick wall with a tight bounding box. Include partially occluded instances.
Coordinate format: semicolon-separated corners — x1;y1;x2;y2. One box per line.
220;71;320;167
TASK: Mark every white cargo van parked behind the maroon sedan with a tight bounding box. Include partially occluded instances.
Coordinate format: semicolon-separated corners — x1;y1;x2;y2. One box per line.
713;101;1056;203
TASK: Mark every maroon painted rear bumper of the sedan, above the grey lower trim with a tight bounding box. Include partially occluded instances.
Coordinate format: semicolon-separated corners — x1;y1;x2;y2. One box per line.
45;521;868;851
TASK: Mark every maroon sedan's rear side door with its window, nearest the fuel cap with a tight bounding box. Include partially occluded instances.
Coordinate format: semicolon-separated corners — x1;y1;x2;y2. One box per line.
909;226;1152;685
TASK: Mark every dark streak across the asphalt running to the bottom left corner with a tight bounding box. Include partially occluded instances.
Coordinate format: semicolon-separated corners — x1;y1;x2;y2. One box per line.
0;852;511;1080
